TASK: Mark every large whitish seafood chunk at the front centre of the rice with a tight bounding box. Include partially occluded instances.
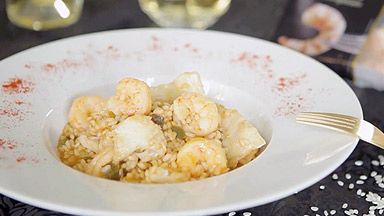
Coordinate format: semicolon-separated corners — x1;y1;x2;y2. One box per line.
113;114;167;162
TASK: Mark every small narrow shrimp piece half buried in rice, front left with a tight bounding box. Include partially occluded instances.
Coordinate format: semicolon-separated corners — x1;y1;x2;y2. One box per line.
85;147;114;177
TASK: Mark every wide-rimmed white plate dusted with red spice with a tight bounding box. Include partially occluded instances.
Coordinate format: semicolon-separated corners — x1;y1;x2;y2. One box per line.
0;29;362;215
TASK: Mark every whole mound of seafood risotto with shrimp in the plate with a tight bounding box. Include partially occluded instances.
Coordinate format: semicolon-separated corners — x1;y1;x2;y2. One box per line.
57;73;265;183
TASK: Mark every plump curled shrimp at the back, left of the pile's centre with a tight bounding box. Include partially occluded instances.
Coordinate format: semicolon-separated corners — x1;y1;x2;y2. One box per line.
107;78;152;116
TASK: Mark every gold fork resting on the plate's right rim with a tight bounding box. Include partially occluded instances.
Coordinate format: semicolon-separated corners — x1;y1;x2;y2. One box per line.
296;112;384;149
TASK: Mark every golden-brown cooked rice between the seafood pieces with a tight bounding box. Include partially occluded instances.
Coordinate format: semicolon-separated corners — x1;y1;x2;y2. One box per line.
57;101;260;183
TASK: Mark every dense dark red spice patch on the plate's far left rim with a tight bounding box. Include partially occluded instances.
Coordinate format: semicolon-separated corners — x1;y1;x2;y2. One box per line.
2;77;35;94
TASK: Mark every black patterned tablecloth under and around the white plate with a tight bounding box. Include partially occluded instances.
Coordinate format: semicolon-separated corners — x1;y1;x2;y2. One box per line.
0;0;384;216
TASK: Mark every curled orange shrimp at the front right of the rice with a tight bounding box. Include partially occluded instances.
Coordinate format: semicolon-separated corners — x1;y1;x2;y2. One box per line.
176;138;228;177
